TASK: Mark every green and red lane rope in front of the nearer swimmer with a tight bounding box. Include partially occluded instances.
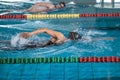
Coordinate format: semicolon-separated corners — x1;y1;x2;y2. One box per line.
0;56;120;64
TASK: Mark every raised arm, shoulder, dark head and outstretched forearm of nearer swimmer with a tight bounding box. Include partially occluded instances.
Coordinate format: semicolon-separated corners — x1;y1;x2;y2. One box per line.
20;28;114;47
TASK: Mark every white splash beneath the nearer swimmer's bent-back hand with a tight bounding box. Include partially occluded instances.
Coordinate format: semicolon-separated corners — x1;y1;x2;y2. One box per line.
11;34;29;47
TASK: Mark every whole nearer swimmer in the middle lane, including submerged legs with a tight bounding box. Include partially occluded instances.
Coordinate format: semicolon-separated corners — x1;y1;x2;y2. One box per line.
0;28;115;50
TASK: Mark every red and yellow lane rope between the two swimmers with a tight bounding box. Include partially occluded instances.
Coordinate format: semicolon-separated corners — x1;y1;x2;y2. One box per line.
0;13;120;20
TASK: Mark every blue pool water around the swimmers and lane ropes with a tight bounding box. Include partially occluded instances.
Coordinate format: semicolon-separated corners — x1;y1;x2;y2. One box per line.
0;2;120;80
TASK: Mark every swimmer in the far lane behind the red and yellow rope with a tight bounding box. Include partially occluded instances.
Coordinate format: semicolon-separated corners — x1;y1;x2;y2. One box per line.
21;2;65;13
